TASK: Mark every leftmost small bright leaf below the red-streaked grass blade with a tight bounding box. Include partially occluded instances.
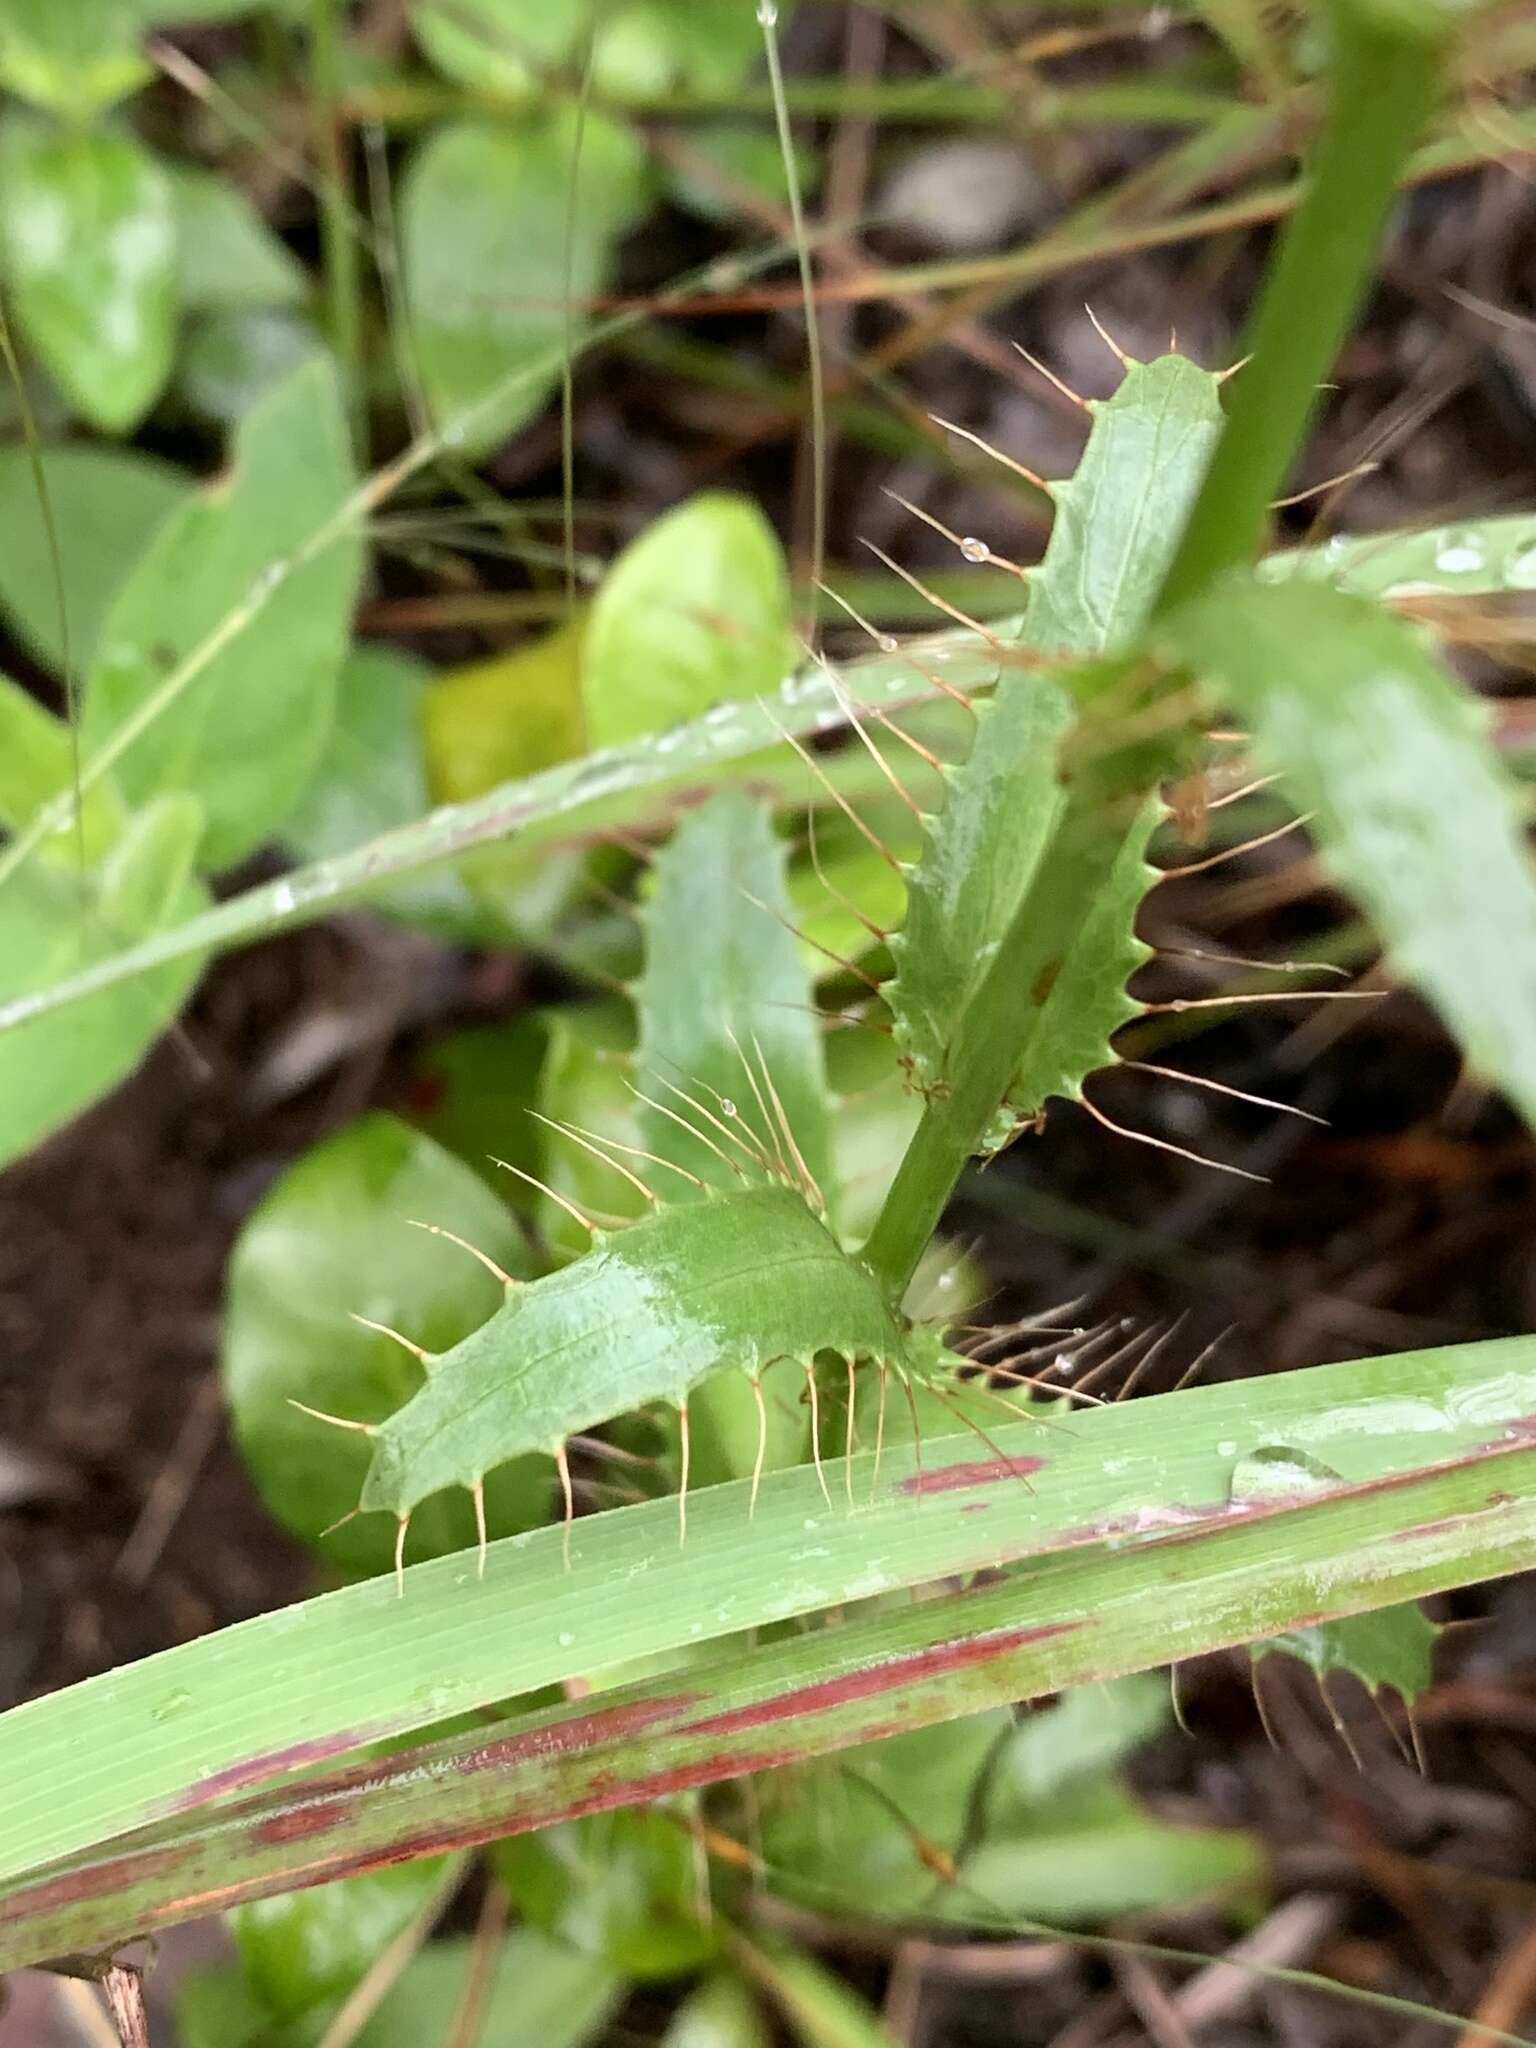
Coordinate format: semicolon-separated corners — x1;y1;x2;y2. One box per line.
225;1855;449;2019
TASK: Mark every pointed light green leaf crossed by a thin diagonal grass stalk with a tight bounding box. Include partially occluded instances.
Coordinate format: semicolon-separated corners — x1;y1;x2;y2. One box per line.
84;362;362;868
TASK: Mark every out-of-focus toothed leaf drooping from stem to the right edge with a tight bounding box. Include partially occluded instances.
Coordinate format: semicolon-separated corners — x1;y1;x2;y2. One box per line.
1167;578;1536;1120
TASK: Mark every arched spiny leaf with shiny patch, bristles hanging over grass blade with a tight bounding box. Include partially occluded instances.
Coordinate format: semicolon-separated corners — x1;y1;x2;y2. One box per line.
362;1186;932;1520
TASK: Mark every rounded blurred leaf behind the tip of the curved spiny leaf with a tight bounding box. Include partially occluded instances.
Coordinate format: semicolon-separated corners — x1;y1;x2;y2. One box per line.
223;1114;549;1573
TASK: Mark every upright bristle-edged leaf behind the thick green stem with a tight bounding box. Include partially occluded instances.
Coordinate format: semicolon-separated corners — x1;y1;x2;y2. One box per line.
885;354;1221;1149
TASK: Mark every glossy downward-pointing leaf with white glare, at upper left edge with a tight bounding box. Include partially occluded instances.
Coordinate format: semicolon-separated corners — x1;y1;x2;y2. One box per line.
0;117;176;434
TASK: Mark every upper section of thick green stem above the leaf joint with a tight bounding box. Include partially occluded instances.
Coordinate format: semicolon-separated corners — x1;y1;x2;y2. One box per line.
1153;0;1446;616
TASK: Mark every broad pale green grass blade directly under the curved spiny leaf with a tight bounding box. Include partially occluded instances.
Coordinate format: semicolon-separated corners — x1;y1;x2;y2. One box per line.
0;1337;1536;1878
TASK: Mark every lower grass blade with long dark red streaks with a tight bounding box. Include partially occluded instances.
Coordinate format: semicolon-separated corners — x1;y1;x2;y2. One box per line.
0;1409;1536;1966
